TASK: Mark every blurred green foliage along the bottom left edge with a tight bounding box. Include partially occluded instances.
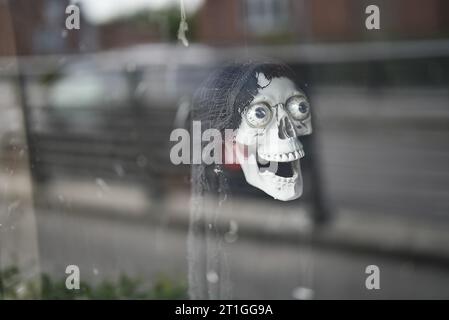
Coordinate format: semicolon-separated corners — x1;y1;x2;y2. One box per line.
0;267;187;300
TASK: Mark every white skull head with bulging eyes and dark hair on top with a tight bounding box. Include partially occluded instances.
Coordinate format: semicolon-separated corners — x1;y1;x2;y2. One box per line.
194;62;312;201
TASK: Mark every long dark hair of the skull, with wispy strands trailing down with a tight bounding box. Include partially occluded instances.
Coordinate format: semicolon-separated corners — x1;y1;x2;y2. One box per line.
188;61;300;299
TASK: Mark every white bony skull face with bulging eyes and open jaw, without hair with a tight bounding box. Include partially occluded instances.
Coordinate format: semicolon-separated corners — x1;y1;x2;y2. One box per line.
236;73;312;201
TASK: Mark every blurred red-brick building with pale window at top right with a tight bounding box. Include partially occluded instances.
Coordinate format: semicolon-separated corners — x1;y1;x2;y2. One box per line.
199;0;449;45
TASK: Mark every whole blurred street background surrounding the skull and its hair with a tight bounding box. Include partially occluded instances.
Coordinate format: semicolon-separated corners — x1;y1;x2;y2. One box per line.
0;0;449;299
